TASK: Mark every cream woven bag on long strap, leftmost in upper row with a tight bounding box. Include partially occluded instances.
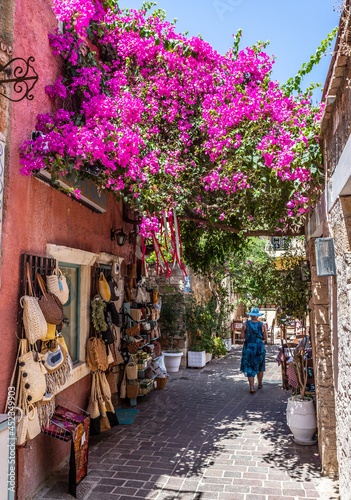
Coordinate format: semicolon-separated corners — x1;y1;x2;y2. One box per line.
20;262;48;344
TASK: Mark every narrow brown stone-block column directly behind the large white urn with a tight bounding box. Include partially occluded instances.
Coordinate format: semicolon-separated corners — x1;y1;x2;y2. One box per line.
307;239;338;476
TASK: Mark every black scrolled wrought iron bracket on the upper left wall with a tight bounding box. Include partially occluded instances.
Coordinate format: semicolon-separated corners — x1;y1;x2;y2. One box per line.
0;56;39;102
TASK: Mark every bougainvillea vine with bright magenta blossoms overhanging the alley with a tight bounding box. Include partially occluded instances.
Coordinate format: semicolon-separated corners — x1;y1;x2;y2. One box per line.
21;0;333;236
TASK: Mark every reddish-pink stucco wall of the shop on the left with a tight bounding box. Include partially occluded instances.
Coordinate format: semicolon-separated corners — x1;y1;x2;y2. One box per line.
0;0;135;499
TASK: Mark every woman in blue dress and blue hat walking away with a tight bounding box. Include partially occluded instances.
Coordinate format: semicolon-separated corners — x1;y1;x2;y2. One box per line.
240;307;267;394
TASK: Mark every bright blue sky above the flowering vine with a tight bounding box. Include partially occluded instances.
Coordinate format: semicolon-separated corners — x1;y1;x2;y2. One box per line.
119;0;340;100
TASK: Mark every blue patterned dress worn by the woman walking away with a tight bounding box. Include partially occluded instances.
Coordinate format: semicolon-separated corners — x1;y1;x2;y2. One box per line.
240;321;266;377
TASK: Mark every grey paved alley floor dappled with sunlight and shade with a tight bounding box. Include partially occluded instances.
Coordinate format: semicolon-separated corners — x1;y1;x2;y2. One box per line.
33;346;339;500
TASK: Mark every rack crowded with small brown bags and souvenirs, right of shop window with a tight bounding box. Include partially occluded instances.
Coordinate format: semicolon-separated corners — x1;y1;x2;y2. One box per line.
87;261;164;418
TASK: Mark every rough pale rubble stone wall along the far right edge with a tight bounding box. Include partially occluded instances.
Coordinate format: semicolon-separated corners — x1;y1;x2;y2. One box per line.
329;197;351;499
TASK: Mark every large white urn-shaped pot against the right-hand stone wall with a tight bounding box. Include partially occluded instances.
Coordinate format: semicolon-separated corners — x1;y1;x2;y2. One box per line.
286;397;317;445
